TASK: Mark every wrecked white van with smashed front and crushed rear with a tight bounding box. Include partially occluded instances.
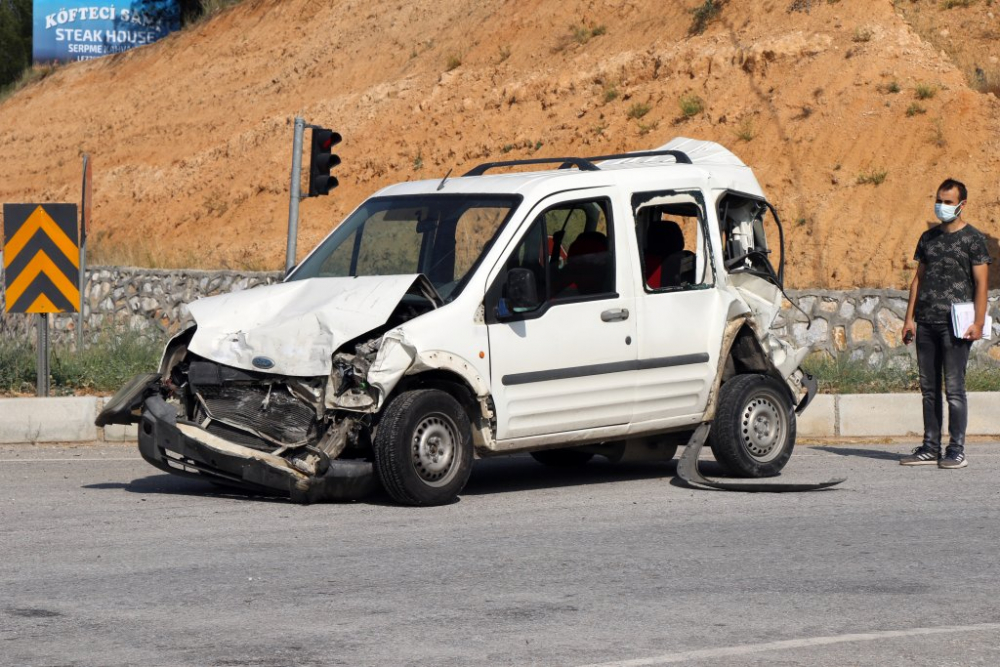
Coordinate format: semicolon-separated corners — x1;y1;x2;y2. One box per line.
98;138;816;505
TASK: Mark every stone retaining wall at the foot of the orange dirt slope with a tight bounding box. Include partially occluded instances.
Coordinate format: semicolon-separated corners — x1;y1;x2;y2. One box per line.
0;267;1000;364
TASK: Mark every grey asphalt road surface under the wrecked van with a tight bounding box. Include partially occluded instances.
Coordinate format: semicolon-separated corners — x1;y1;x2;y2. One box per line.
0;443;1000;667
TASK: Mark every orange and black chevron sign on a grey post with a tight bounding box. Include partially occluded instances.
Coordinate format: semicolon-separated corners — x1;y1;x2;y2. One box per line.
3;204;80;313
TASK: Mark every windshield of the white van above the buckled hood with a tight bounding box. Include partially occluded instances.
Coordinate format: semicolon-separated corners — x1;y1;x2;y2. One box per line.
288;194;521;301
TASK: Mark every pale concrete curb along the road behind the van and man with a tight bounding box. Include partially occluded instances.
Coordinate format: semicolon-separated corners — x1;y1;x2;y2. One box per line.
0;392;1000;445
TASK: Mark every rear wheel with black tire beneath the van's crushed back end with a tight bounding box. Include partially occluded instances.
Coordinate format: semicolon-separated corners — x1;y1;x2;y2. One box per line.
708;375;795;477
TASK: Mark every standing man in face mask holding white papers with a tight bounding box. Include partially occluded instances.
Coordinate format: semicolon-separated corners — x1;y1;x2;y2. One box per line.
900;178;990;469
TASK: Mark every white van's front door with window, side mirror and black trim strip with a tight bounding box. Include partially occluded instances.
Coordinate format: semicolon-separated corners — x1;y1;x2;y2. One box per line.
486;192;636;449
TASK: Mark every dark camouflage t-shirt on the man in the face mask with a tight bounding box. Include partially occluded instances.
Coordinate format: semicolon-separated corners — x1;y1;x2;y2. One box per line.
913;224;991;322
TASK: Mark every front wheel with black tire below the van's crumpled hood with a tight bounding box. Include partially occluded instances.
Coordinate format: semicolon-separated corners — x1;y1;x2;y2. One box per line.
374;389;472;506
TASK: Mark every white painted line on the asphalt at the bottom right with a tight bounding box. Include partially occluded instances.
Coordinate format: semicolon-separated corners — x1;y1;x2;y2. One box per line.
583;623;1000;667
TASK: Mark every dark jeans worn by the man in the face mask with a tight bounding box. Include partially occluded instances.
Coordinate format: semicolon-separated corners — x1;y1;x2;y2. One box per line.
917;322;972;452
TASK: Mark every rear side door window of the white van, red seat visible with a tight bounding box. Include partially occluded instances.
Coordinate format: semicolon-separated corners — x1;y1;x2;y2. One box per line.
632;192;715;291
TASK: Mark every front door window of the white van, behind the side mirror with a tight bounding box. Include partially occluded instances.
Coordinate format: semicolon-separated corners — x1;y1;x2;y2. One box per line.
507;199;615;312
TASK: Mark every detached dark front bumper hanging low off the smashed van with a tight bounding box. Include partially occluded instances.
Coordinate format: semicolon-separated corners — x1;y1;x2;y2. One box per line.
139;395;376;504
